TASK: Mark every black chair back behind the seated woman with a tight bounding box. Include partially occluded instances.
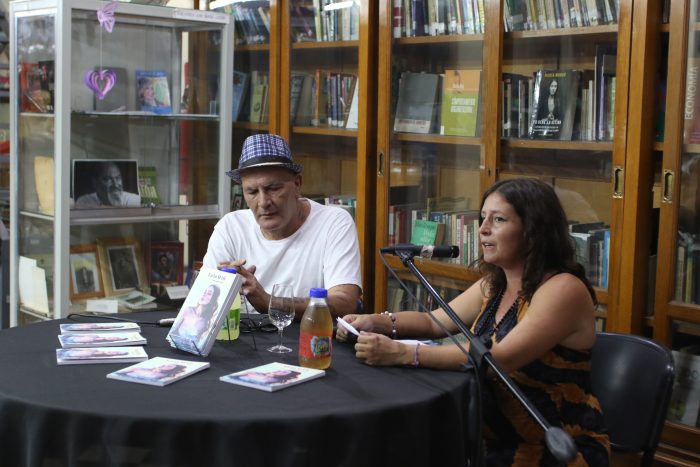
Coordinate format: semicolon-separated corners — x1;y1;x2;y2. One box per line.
591;332;675;466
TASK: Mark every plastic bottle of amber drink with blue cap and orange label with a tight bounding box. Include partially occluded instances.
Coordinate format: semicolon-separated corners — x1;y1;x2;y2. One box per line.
299;288;333;370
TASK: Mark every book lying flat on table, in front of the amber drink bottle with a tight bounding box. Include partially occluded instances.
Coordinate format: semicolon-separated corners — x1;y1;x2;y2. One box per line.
219;362;326;392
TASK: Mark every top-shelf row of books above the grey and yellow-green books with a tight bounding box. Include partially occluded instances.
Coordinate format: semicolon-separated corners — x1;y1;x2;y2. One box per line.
392;0;484;38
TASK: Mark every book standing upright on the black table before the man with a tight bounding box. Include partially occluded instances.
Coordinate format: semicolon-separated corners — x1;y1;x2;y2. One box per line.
167;268;242;357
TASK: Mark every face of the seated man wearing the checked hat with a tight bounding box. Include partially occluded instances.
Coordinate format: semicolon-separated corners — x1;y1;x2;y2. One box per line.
241;167;303;240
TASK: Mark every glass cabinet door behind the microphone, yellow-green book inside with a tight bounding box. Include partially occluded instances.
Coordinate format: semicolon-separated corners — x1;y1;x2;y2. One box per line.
374;1;486;311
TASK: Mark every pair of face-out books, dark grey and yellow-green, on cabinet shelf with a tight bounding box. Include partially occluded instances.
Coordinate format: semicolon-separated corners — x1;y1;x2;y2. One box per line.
394;69;481;136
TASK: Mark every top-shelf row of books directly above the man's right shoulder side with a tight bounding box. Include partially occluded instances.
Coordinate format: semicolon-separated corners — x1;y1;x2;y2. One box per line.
290;0;360;42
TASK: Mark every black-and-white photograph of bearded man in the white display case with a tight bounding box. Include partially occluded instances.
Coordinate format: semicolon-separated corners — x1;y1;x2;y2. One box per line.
71;159;141;209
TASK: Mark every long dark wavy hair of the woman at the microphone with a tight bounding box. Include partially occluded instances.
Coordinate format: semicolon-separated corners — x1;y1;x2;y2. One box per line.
477;178;597;303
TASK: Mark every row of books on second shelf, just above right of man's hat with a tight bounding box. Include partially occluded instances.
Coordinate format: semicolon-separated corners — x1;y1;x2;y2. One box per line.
289;69;359;129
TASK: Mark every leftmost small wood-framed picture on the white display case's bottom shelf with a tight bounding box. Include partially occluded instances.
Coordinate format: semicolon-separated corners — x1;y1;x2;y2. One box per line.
69;243;105;300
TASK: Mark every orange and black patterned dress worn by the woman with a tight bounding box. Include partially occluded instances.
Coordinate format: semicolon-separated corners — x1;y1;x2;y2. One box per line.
473;295;610;467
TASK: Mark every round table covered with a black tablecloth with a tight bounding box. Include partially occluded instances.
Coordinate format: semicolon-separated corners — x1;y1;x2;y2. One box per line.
0;312;472;467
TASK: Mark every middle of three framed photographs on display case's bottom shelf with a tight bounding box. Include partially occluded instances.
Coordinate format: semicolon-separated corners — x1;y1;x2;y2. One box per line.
97;237;146;297
